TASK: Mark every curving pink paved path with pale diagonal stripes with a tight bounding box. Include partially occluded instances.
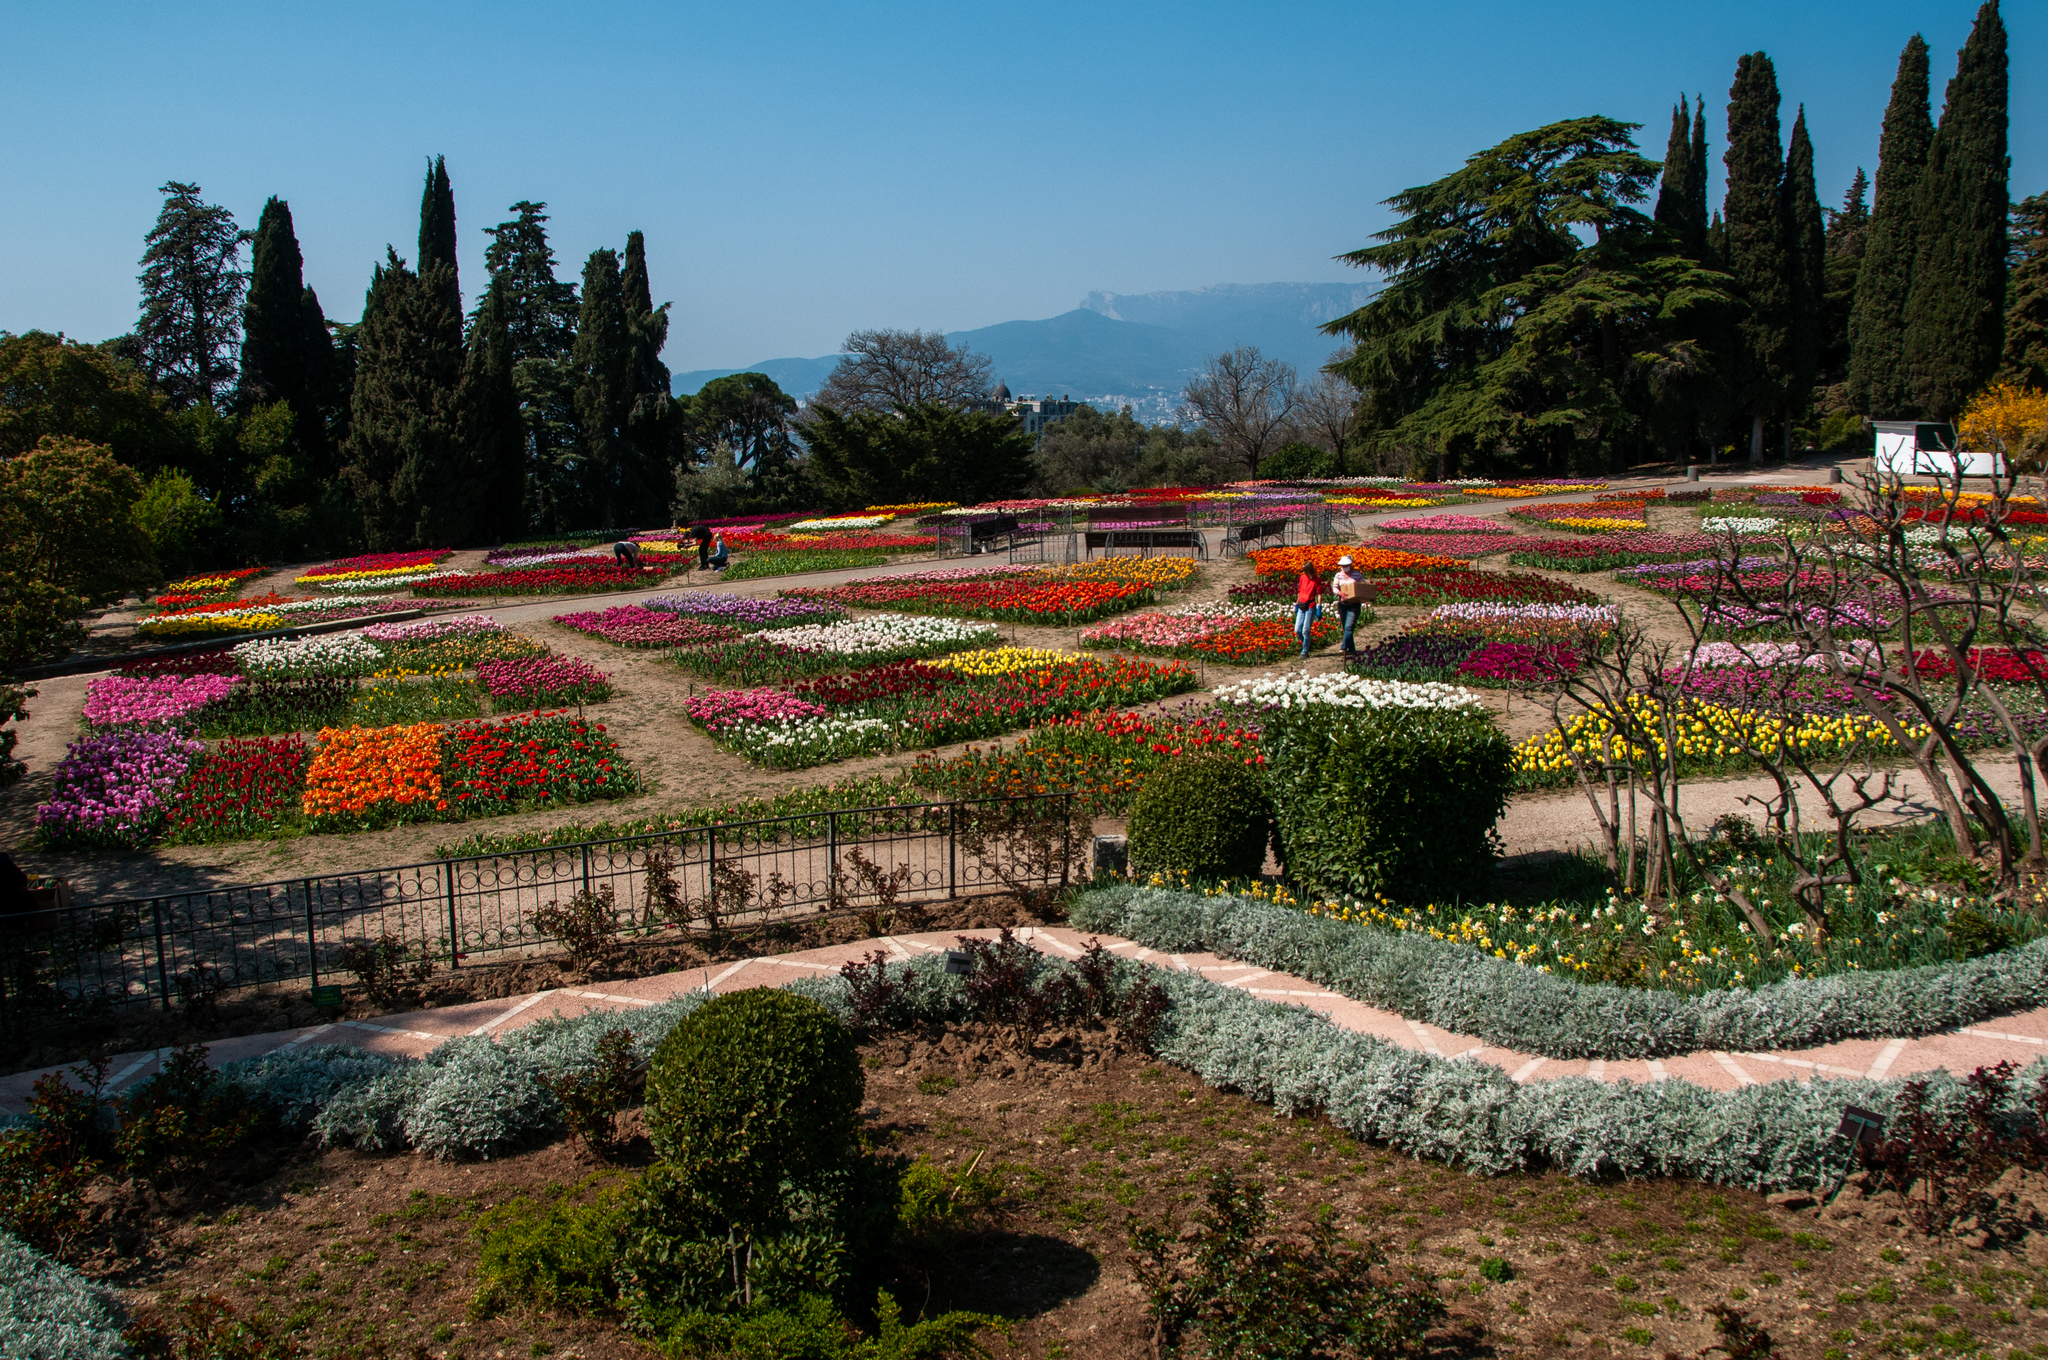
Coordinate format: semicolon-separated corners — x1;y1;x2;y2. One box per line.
0;928;2048;1112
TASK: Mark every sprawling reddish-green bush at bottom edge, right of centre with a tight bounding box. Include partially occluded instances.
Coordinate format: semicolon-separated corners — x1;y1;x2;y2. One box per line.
1130;1172;1448;1360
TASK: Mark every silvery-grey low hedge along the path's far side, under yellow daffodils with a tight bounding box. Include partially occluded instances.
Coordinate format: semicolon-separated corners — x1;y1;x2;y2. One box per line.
1071;885;2048;1086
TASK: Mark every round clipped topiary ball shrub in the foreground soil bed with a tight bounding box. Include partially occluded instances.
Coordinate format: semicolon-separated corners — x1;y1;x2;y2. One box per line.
647;987;866;1225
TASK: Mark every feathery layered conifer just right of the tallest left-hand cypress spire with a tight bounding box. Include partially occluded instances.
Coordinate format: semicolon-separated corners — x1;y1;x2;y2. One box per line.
477;199;588;528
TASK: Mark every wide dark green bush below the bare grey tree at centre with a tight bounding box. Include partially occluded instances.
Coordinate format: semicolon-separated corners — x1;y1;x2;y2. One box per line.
803;401;1032;516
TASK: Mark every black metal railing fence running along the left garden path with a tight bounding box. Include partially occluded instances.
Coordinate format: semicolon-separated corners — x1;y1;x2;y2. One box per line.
0;793;1090;1028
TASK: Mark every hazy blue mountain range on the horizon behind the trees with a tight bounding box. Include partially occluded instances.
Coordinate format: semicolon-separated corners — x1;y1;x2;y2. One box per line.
674;283;1374;420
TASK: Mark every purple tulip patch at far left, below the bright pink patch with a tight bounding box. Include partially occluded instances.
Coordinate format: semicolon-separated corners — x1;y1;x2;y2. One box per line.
35;727;203;850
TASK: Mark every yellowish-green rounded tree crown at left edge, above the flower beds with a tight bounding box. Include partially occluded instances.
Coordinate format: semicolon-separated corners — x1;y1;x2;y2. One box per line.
0;436;156;670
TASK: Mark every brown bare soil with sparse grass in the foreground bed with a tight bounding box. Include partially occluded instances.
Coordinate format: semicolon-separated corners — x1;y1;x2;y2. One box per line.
88;1026;2048;1360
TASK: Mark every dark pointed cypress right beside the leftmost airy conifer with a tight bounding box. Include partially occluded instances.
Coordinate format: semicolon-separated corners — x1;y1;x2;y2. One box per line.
236;199;342;477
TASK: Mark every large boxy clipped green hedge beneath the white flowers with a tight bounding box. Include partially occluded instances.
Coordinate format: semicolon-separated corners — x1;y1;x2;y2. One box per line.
1264;705;1513;901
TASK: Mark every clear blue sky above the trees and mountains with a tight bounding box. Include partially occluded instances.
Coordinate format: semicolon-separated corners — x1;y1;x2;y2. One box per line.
0;0;2048;371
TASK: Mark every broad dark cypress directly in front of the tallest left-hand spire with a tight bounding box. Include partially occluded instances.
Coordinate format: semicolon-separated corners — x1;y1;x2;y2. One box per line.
344;248;479;551
